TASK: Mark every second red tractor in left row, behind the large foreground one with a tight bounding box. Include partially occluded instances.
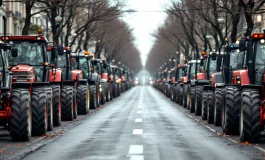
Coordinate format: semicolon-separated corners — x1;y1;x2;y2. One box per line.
49;46;83;120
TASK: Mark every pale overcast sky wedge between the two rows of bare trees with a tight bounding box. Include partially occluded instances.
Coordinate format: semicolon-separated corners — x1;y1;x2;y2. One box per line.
123;0;168;65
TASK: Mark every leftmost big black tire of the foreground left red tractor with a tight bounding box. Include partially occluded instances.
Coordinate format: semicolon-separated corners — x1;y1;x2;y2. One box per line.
10;88;32;141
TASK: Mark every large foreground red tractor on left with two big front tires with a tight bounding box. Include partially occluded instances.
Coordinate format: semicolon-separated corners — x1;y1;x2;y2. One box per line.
0;34;59;141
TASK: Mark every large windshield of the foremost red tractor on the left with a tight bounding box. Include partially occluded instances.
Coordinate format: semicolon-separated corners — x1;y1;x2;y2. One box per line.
8;41;44;66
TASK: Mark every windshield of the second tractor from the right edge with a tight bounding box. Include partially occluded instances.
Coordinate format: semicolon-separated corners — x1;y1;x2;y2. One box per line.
229;50;245;70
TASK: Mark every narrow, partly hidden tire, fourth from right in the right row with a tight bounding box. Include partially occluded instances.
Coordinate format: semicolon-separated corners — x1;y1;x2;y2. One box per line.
207;91;214;124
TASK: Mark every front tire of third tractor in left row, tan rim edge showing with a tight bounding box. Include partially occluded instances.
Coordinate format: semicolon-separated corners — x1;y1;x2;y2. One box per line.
76;85;90;115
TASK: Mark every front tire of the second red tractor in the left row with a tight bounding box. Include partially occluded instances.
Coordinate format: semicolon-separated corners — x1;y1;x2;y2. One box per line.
61;85;75;121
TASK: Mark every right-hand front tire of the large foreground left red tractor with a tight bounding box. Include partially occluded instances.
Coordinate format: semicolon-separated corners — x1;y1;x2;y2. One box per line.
31;88;49;136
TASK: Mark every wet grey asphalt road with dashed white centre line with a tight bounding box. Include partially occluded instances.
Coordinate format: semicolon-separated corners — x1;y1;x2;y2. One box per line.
0;86;265;160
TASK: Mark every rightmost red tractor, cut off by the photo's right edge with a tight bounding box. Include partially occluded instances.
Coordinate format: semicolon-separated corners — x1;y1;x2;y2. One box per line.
225;30;265;142
